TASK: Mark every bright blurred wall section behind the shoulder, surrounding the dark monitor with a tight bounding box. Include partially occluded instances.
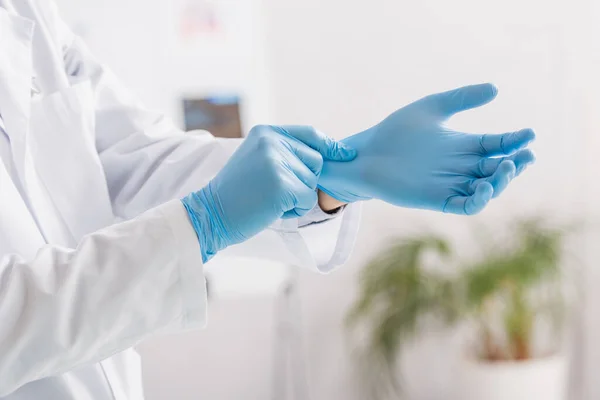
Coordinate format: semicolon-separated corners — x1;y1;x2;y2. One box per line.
56;0;270;129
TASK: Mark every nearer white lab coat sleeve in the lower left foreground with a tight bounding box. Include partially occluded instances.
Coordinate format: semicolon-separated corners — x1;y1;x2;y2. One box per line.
0;200;206;398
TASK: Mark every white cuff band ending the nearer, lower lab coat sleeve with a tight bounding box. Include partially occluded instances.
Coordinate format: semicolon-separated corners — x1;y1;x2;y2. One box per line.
159;200;207;329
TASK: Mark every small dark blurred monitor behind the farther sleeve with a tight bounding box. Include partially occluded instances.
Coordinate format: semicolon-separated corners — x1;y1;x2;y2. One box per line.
183;96;242;138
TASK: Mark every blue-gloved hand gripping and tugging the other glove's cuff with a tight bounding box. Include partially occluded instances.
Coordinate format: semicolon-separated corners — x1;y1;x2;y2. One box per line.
182;126;356;262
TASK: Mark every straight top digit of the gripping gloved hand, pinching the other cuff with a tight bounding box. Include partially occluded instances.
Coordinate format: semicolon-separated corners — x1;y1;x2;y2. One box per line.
273;125;356;161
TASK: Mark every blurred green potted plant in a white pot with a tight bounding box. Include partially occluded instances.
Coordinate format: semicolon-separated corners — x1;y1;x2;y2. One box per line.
348;220;568;400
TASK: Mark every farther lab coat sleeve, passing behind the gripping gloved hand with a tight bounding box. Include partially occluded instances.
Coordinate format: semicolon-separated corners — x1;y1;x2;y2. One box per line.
51;7;359;272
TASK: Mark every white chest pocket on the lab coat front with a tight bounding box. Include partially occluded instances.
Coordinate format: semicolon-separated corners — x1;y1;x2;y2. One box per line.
30;81;112;240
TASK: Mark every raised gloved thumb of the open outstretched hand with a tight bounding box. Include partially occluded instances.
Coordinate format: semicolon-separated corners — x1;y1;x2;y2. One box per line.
425;83;498;118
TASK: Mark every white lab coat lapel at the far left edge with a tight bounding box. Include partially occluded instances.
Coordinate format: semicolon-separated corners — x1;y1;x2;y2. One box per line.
0;8;35;191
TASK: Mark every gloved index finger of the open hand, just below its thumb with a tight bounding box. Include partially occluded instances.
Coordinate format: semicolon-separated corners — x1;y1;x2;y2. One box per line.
472;128;535;157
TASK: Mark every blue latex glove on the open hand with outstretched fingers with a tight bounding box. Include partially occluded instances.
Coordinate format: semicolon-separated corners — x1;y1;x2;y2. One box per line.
319;84;535;214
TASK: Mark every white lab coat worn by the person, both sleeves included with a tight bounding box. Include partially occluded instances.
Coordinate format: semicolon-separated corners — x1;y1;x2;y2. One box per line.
0;0;357;400
